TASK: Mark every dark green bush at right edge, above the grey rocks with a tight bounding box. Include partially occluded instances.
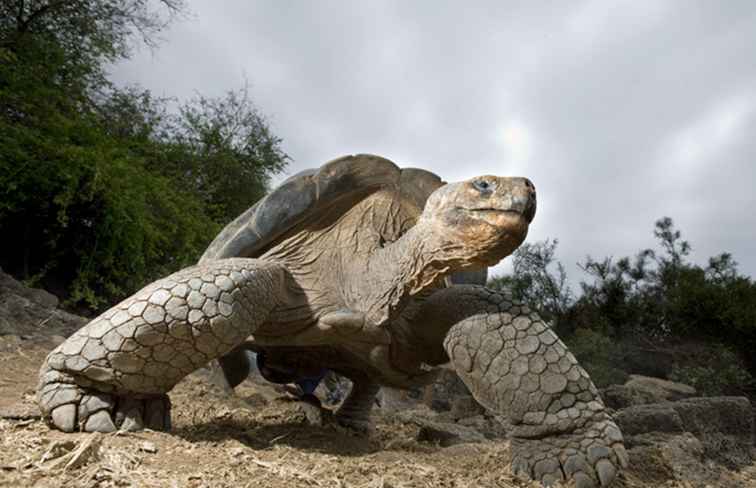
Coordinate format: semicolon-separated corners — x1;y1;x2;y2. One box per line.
576;218;756;352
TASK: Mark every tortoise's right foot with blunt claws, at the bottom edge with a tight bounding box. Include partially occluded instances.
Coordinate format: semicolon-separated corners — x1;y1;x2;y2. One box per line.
512;415;628;488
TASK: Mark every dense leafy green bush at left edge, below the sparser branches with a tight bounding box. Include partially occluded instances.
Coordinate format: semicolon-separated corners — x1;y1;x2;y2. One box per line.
0;81;219;308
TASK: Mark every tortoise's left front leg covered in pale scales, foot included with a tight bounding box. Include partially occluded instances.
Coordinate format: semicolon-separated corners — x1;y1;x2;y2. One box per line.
37;258;286;432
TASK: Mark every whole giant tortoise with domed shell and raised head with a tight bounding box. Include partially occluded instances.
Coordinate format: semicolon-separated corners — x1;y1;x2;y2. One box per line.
38;155;627;488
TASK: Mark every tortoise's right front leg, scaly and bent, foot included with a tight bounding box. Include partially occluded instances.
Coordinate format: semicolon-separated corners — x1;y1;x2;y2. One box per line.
423;286;627;488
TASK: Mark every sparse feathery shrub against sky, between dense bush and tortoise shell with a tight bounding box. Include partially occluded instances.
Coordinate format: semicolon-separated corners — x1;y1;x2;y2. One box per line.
93;86;288;224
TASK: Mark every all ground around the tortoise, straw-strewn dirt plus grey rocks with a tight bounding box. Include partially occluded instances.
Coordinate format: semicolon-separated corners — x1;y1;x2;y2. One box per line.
0;273;756;488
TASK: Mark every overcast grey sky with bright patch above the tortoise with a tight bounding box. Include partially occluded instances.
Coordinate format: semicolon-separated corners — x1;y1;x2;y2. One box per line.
112;0;756;280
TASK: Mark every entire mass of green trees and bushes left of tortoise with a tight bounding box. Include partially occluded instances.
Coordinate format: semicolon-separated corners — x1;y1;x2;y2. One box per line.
0;0;287;309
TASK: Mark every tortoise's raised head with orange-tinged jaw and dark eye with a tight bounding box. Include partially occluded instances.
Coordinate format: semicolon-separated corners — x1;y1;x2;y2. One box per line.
418;175;536;266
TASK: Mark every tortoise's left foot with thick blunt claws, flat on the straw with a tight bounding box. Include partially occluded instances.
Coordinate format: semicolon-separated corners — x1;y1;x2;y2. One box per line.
38;371;171;432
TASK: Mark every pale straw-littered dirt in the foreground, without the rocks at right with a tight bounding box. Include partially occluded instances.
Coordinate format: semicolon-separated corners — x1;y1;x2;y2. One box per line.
0;336;756;488
